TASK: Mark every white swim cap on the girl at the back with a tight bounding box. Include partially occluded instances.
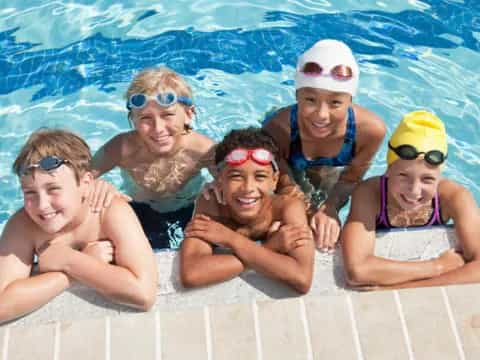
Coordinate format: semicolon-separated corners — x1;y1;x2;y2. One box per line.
295;39;360;96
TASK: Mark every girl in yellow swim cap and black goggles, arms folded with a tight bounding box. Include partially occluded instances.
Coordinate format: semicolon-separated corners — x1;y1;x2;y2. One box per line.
342;111;480;287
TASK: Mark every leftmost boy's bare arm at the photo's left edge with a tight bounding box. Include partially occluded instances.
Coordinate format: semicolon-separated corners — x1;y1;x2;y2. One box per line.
0;212;70;323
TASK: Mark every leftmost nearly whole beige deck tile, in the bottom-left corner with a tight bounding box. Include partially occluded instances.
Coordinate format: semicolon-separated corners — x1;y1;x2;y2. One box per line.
8;323;56;360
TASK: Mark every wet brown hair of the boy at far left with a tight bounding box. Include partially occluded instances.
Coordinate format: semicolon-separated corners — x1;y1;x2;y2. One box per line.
12;128;92;183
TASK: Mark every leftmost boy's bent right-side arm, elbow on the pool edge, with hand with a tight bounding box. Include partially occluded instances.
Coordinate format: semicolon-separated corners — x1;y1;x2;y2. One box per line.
39;199;158;310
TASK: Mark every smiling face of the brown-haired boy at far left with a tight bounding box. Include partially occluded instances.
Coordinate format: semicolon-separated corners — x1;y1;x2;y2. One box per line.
20;165;93;234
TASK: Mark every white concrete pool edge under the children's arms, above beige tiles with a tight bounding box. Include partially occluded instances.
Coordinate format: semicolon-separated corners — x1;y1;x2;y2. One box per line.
3;227;455;326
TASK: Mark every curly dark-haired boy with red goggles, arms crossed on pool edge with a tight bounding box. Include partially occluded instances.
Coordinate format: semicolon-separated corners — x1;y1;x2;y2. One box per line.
180;128;315;293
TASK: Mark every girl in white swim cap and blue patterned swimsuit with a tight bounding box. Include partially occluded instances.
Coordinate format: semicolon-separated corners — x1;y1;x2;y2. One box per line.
263;39;385;250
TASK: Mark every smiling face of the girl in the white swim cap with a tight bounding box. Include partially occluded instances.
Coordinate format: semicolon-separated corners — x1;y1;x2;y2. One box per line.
297;88;352;139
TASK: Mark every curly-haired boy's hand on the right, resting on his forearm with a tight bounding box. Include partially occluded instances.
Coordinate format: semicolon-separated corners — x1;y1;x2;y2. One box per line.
265;221;312;254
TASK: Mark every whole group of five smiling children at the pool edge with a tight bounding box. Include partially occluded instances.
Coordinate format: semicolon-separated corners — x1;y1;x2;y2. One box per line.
0;40;480;322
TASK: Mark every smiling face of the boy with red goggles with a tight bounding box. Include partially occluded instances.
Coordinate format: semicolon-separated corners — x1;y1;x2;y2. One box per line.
219;160;278;224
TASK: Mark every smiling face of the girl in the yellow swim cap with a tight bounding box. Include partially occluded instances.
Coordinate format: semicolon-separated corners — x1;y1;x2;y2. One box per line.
387;157;441;210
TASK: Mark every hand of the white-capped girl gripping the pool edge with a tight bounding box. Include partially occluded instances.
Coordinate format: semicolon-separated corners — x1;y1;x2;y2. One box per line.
310;210;340;252
